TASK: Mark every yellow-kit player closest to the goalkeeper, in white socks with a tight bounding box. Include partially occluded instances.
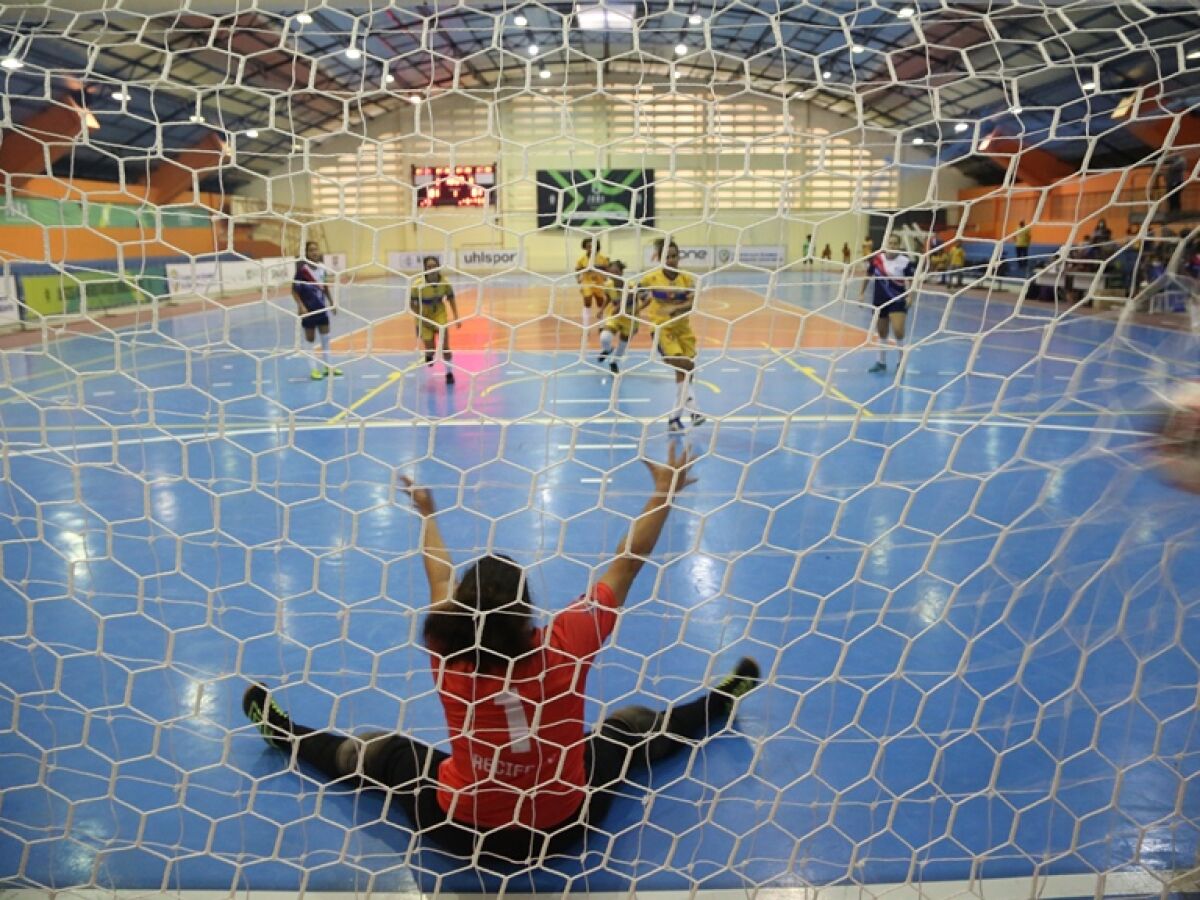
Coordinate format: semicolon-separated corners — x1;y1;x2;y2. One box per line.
637;241;704;432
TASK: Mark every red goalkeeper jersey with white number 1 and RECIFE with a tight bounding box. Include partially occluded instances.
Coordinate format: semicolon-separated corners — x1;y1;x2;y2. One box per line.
433;584;617;829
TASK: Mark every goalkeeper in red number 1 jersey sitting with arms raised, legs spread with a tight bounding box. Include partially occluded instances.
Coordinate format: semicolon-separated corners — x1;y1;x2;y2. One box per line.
242;446;758;863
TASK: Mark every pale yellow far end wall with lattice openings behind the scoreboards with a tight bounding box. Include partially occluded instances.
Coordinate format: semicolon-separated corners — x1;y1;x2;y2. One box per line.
239;88;973;277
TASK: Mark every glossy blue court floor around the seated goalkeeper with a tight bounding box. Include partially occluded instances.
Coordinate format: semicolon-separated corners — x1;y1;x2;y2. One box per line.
0;276;1200;892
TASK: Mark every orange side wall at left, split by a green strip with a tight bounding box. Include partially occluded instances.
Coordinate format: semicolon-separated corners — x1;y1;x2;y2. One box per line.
0;176;230;269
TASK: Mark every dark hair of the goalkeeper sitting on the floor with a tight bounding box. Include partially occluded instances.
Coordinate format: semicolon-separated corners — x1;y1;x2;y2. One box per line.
425;554;533;671
